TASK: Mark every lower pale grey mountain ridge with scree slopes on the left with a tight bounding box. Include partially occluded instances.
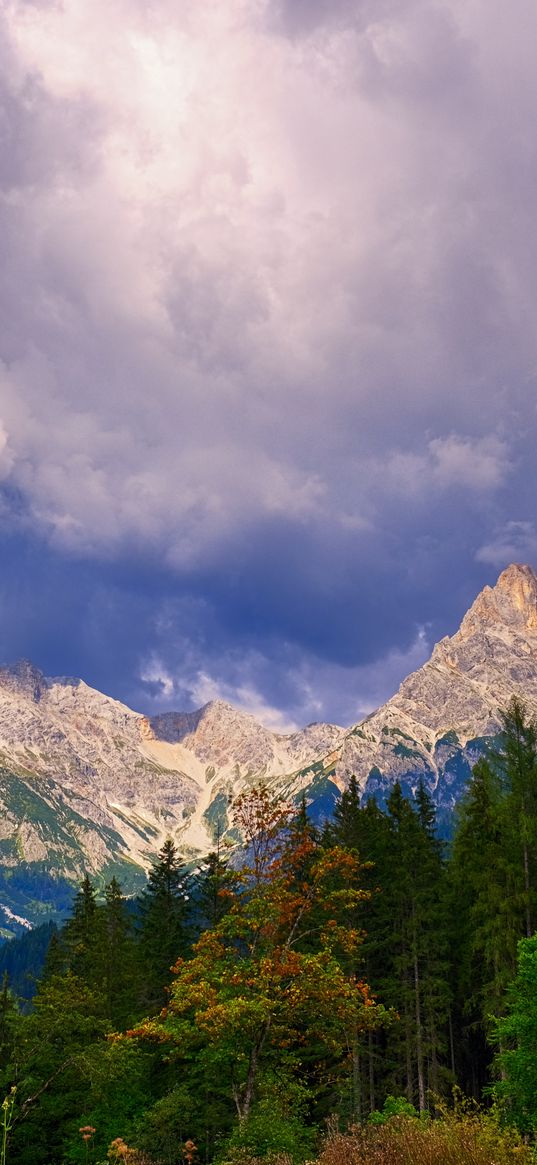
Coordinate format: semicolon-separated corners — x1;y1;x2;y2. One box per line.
0;661;342;937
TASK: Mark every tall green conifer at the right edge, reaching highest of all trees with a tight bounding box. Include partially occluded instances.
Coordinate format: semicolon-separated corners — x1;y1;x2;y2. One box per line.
450;698;537;1095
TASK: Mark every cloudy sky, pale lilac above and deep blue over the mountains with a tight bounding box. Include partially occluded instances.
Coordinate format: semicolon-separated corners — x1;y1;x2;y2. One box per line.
0;0;537;730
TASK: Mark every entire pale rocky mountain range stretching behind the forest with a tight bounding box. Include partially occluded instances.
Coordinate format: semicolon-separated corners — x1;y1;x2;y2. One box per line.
0;565;537;935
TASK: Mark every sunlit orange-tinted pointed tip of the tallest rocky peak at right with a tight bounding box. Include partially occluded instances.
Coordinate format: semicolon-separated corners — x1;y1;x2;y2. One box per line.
455;563;537;640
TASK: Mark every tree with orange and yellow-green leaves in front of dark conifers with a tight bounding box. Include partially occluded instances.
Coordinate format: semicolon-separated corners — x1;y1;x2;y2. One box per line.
133;786;384;1122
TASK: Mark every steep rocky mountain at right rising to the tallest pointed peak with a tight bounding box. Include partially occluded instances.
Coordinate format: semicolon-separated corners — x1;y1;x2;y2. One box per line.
335;565;537;818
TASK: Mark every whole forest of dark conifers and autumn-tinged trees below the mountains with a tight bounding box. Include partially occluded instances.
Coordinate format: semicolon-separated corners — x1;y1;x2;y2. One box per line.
0;699;537;1165
